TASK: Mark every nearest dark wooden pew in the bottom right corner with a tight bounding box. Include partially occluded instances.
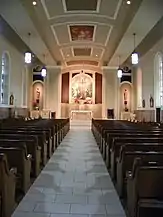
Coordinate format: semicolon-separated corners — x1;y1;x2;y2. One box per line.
127;158;163;217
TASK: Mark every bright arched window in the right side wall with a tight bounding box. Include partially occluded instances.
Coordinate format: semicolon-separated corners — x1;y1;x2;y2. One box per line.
154;53;163;107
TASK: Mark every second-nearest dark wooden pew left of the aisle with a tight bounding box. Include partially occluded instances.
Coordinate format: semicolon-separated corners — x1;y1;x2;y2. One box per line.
0;145;32;193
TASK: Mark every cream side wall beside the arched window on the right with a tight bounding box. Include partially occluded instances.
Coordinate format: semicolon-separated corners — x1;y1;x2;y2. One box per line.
139;38;163;109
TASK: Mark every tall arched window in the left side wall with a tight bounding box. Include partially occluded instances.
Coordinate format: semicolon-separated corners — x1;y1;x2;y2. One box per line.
0;52;10;105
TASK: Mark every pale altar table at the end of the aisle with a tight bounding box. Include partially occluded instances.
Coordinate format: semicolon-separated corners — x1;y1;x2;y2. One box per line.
70;110;92;120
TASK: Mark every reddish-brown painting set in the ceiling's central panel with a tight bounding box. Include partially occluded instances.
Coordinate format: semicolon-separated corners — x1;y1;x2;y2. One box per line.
69;25;94;41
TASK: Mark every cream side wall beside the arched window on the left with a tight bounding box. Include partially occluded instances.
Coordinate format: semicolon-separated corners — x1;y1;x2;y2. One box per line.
0;35;28;107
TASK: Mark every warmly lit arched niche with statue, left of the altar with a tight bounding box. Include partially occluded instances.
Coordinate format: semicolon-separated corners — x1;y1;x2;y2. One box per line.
32;82;43;110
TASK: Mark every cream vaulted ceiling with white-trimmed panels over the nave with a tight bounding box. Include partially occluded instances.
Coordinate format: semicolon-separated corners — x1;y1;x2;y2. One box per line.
0;0;163;66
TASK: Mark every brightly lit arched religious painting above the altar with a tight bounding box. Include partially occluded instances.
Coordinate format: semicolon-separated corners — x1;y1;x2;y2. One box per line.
71;73;92;104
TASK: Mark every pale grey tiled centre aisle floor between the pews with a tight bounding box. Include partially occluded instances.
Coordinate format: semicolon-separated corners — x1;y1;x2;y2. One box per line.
12;120;125;217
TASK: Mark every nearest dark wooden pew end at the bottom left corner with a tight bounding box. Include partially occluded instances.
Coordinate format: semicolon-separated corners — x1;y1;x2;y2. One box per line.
0;153;16;217
